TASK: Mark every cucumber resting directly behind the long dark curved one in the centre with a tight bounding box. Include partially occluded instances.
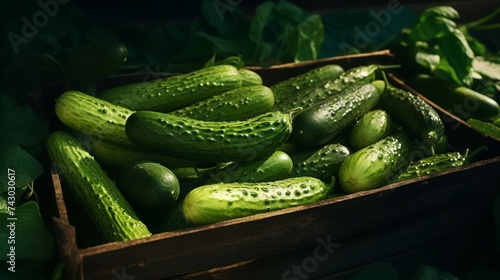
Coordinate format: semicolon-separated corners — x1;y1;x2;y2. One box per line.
170;85;274;121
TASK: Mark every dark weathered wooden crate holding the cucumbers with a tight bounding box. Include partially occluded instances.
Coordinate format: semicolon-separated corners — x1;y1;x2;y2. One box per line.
41;52;500;279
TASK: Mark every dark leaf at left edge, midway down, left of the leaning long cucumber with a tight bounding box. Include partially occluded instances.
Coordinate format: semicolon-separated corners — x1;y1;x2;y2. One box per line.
0;143;43;193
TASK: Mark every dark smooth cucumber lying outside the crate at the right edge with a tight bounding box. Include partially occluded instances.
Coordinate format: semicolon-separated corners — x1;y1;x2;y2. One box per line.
408;74;500;121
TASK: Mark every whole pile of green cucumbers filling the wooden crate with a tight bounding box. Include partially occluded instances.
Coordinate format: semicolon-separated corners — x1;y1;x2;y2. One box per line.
47;64;480;242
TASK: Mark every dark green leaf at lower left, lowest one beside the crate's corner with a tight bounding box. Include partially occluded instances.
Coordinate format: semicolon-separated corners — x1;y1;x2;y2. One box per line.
0;201;54;261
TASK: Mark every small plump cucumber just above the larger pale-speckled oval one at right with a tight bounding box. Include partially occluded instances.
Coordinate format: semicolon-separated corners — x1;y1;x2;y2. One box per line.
349;109;393;151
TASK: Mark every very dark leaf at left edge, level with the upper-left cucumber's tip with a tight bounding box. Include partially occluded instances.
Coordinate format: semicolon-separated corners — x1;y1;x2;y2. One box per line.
0;92;47;146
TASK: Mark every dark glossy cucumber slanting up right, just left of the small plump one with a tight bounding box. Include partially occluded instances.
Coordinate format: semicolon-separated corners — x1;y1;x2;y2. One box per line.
290;83;382;147
